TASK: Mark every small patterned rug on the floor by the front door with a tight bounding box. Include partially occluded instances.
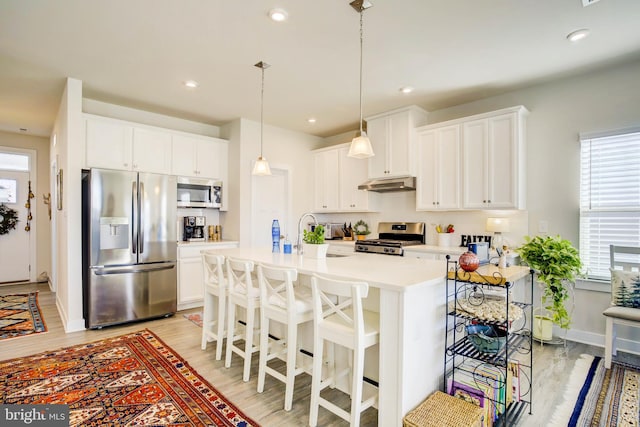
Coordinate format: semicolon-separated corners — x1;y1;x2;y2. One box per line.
0;292;47;340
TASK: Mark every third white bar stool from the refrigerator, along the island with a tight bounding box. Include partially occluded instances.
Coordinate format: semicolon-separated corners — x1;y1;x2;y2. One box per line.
257;264;313;411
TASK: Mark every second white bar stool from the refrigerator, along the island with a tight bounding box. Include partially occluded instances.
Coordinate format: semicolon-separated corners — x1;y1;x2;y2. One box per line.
224;257;260;382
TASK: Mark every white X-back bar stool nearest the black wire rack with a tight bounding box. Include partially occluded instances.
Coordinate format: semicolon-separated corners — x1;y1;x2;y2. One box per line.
309;274;380;427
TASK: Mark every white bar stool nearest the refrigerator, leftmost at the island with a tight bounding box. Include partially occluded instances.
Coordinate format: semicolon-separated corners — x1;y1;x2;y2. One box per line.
201;251;228;360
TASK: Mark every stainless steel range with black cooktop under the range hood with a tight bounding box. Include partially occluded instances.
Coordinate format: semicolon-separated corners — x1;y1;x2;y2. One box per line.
356;222;425;256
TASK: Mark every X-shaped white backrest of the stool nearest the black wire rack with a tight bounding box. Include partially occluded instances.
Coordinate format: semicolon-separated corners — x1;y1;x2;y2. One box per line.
311;274;369;344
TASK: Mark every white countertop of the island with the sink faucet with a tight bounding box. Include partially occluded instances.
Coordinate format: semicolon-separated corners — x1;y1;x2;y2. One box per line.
204;246;446;292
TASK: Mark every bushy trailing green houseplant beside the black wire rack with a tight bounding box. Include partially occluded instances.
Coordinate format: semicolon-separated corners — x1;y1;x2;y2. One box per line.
516;236;582;329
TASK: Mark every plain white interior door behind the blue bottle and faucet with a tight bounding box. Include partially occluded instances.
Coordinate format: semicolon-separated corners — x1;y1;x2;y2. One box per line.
251;167;296;250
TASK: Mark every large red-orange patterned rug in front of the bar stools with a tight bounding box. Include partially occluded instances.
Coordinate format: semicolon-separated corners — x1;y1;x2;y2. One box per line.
0;330;258;427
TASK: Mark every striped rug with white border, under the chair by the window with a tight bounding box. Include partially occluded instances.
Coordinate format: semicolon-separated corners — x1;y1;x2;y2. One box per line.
549;354;640;426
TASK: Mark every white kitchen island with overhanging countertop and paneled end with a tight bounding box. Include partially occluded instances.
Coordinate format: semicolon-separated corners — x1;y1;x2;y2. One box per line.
206;248;529;427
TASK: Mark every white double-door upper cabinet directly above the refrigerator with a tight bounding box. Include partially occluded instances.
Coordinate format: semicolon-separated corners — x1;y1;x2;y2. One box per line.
85;115;171;174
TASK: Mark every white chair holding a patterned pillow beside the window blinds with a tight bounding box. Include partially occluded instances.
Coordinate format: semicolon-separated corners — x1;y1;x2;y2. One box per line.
602;245;640;369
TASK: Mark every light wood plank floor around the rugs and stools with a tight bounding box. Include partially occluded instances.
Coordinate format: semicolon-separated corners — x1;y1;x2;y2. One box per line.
0;283;640;427
